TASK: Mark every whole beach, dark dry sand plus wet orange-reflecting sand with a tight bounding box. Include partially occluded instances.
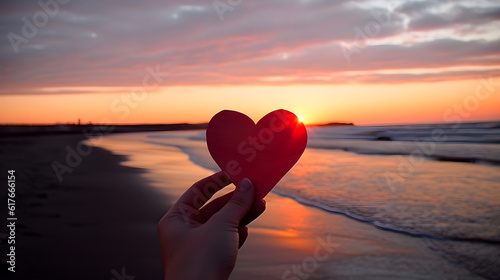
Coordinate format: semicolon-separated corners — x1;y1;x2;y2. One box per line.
1;127;494;280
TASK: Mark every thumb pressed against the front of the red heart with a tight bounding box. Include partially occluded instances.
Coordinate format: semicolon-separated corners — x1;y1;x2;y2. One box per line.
212;178;255;228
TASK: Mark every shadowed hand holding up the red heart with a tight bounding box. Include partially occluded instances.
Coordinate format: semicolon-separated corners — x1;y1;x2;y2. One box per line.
158;171;265;280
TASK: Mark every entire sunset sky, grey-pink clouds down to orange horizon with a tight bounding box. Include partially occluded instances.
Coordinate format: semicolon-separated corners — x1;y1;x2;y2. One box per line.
0;0;500;125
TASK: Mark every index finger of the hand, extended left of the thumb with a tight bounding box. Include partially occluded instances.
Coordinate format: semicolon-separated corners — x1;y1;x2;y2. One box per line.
175;171;231;209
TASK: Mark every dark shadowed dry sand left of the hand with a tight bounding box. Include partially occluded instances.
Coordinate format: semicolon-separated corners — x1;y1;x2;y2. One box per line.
0;136;169;280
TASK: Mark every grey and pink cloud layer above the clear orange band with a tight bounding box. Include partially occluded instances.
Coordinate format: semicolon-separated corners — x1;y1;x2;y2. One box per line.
0;0;500;94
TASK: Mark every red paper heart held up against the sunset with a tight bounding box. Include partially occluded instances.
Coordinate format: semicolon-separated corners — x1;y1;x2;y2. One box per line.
207;110;307;198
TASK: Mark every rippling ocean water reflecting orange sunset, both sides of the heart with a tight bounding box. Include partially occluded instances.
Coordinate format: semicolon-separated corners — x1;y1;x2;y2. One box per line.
91;122;500;279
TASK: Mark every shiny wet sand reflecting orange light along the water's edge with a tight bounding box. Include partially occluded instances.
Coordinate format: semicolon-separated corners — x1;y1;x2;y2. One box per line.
93;134;483;280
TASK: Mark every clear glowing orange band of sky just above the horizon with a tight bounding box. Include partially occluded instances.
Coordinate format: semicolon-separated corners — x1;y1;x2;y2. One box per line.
0;79;500;125
